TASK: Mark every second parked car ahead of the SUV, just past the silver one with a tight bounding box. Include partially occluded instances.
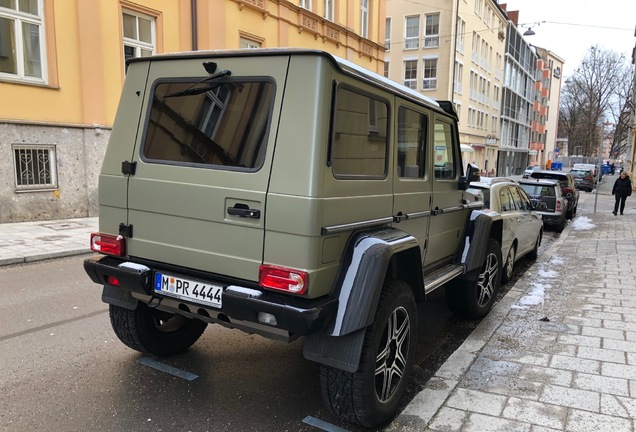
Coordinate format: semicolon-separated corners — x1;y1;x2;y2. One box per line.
519;178;568;232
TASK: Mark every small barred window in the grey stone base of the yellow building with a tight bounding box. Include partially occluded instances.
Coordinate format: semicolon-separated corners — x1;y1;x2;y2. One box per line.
13;145;57;191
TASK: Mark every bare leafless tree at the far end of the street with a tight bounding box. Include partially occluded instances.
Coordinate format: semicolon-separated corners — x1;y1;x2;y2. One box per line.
559;46;631;156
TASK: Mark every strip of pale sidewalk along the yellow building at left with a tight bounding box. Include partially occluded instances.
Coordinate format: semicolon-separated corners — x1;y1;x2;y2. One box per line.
0;217;97;266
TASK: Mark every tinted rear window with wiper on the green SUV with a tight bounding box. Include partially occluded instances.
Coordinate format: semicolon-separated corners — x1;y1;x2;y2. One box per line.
142;80;275;171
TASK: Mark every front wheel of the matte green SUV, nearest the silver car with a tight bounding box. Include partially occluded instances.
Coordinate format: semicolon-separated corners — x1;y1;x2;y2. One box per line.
446;239;503;319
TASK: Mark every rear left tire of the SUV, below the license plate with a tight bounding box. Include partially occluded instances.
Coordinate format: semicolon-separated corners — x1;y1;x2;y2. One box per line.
109;302;207;357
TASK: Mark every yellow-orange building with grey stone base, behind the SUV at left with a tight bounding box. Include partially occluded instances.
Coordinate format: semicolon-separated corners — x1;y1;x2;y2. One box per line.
0;0;386;223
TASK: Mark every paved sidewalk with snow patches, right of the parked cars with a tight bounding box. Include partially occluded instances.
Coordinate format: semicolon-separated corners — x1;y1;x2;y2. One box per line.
386;184;636;432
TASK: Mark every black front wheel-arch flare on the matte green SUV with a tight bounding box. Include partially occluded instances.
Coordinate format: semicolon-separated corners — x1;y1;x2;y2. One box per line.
460;210;503;274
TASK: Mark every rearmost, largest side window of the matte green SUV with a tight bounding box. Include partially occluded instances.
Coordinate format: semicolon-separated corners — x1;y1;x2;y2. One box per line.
332;87;389;179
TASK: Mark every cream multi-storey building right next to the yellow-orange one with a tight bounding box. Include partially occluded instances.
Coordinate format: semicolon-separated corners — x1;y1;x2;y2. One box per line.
385;0;508;175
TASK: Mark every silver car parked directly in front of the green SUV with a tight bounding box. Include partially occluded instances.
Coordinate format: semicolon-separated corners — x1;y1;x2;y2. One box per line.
468;177;546;282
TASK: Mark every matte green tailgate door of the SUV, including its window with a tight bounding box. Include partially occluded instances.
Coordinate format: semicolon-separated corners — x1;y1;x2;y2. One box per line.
127;56;288;280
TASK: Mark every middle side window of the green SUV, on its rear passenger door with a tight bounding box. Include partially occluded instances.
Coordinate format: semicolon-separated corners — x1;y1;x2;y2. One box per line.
398;107;428;178
